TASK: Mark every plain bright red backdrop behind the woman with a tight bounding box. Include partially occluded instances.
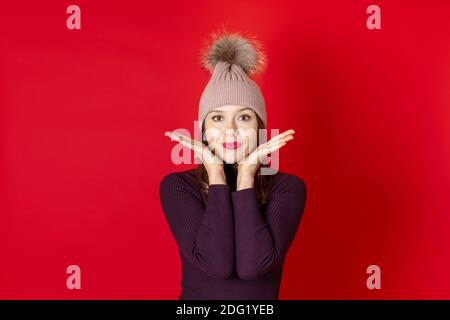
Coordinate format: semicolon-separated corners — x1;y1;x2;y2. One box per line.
0;0;450;299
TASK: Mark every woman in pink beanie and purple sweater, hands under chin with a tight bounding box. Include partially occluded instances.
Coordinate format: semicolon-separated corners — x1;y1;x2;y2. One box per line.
160;32;306;299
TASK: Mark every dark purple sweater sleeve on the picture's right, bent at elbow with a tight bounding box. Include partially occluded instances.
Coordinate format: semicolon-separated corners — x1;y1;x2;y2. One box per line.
231;175;306;280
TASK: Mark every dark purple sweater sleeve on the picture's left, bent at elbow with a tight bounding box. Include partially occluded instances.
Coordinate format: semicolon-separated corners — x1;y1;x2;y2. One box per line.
160;173;235;279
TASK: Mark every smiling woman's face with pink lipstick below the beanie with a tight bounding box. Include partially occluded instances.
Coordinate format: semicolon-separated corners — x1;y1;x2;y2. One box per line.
204;105;258;164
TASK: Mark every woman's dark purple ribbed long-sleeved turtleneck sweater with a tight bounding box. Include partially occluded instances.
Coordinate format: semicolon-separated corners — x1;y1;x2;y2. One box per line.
160;170;306;300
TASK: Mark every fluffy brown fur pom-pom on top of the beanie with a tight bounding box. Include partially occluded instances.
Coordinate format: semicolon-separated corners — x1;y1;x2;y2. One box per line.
201;27;267;76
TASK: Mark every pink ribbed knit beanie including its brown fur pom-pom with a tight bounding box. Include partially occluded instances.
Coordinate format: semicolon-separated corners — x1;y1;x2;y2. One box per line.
198;31;267;129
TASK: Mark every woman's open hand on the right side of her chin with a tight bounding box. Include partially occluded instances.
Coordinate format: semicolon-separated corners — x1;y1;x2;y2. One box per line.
238;129;295;177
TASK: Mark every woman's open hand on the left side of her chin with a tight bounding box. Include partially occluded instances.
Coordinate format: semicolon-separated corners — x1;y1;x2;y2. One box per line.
164;131;223;176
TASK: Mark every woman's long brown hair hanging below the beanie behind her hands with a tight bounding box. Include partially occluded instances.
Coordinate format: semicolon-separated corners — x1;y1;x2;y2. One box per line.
193;113;277;207
